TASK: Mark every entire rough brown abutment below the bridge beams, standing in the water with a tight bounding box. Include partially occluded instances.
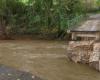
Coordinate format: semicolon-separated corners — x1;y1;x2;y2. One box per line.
67;41;100;71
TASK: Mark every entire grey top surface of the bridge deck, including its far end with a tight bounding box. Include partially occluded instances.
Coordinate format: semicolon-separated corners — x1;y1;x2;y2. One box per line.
71;14;100;32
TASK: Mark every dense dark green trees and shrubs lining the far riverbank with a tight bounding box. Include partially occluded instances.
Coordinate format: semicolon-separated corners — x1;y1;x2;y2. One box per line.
0;0;98;37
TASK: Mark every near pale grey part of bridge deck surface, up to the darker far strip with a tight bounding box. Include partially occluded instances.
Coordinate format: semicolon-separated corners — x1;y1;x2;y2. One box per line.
70;20;100;32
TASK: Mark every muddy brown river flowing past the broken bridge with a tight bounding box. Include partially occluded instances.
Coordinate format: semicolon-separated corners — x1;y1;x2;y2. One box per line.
0;40;100;80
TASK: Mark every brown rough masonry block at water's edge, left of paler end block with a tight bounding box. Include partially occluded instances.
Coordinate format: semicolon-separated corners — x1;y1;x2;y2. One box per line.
68;41;93;63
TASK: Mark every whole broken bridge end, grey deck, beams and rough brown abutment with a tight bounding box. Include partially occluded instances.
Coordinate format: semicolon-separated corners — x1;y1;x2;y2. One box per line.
67;17;100;71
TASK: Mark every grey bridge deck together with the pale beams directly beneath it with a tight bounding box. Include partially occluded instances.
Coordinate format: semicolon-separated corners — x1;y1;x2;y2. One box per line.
70;20;100;40
